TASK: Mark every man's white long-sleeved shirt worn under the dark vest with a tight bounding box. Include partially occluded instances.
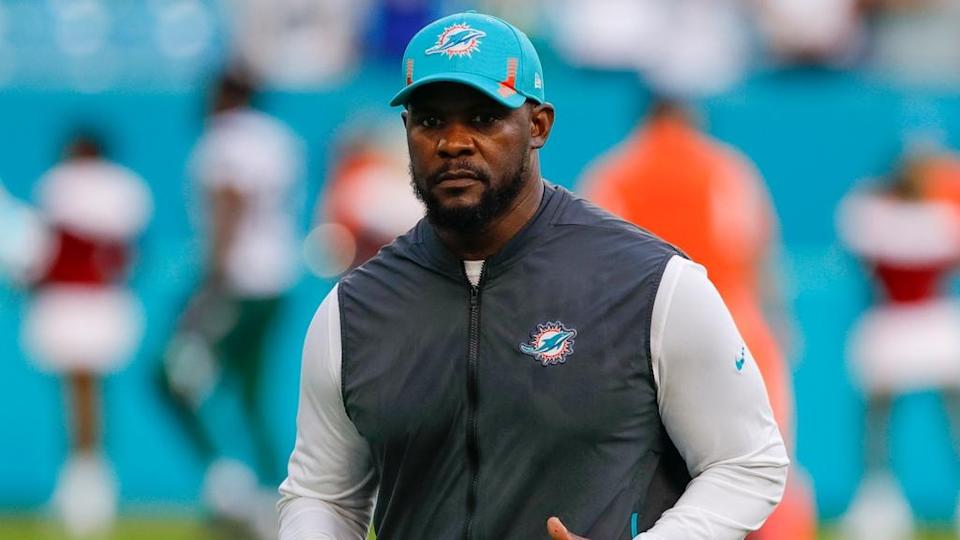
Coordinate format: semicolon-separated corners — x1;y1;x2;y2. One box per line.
279;257;789;540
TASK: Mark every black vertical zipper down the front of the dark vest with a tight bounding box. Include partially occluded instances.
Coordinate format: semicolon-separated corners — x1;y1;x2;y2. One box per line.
463;268;483;540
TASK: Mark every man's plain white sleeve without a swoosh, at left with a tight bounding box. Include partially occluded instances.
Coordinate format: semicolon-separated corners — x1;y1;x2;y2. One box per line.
278;287;377;540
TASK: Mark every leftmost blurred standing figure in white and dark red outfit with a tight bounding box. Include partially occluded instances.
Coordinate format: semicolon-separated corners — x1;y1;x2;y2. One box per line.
23;133;152;537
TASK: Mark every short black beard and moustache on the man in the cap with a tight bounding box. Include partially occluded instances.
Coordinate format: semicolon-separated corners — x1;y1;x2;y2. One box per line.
410;149;530;233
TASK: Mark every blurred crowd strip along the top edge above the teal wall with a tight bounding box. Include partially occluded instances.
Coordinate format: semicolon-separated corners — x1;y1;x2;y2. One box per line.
0;0;960;90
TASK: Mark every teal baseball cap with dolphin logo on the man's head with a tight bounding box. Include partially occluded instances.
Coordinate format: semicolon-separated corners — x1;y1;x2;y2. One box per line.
390;11;544;108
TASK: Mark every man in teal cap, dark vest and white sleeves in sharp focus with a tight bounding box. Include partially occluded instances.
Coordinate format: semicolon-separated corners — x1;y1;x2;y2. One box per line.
280;13;788;540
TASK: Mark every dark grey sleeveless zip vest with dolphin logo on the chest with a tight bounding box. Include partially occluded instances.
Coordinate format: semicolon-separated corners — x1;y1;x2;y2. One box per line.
339;184;689;540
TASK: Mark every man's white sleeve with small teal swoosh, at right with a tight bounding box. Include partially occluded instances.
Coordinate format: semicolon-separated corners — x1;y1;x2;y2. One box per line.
637;257;789;540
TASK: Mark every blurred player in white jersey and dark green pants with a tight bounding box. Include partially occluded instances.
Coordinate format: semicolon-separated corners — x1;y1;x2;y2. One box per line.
161;74;302;534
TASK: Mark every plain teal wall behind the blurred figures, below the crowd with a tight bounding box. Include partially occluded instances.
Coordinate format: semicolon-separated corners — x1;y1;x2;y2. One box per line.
0;62;960;521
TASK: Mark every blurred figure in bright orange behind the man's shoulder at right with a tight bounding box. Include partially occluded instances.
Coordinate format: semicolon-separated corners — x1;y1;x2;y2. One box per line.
584;98;816;540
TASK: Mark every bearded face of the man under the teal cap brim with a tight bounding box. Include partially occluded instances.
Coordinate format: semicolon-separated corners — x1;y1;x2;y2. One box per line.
404;83;531;232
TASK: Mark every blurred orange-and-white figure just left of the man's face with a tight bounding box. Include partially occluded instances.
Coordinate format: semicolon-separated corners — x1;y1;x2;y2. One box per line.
308;113;423;277
